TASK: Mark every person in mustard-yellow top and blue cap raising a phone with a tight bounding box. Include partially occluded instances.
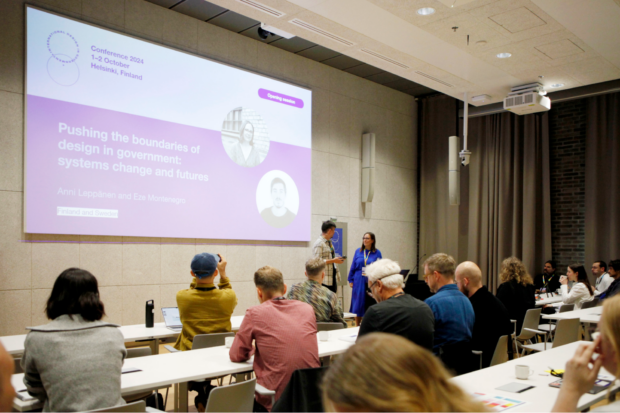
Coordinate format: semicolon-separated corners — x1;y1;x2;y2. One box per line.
174;252;237;351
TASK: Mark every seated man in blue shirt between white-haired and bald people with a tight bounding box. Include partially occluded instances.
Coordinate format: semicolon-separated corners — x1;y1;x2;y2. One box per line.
424;253;475;354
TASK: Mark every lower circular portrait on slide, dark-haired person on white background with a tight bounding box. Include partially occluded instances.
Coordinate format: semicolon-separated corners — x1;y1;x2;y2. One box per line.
256;171;299;228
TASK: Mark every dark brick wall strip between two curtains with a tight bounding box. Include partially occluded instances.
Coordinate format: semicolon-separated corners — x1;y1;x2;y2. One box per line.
552;99;590;274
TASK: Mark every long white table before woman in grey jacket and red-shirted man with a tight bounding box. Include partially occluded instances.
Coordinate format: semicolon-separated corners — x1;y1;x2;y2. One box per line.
11;327;359;413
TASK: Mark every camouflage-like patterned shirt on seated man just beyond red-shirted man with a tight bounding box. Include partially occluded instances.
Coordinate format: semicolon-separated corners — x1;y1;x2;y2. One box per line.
286;280;347;327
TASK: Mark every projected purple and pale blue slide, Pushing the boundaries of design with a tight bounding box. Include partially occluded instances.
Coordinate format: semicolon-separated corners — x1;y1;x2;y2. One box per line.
25;7;312;241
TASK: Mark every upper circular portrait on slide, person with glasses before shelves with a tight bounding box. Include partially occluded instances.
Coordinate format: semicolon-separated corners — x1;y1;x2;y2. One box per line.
222;107;269;168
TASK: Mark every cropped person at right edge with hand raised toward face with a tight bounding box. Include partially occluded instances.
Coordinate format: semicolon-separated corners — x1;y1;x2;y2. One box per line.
551;297;620;413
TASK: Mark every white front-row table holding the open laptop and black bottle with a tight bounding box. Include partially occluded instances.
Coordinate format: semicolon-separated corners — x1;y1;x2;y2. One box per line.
0;313;355;355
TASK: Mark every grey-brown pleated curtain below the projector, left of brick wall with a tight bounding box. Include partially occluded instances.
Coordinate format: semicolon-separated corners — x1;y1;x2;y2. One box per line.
461;113;551;291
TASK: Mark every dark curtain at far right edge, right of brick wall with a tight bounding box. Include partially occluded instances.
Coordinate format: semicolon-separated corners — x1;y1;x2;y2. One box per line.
585;93;620;268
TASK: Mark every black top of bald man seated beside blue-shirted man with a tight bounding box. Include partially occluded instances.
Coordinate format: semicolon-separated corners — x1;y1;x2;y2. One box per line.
469;285;513;368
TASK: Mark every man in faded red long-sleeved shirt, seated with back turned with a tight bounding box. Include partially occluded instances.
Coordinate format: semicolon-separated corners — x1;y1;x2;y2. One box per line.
230;266;321;411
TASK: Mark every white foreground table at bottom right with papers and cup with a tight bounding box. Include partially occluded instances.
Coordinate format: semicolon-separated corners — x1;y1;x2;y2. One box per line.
452;341;620;412
